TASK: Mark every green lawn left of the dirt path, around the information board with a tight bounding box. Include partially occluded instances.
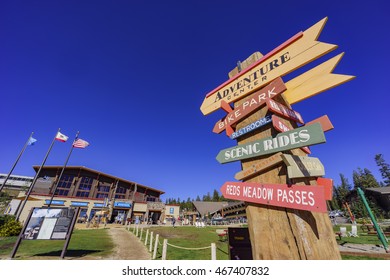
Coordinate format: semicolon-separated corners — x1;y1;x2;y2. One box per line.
0;229;114;260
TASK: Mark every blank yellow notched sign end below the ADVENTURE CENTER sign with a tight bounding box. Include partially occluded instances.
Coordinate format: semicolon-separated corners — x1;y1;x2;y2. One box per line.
284;53;355;104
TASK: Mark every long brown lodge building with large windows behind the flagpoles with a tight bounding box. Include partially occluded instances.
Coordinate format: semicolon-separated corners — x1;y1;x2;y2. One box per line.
7;166;166;224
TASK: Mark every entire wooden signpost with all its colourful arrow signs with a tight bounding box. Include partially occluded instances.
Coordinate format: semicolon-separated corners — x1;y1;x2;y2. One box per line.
200;18;354;259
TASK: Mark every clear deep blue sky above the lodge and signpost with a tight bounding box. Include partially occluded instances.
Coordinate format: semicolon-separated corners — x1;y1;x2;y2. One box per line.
0;0;390;199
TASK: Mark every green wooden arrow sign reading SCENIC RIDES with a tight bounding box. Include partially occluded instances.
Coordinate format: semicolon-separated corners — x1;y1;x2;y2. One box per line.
217;123;326;163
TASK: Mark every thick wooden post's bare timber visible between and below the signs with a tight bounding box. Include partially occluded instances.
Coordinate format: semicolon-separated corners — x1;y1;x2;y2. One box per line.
235;83;341;260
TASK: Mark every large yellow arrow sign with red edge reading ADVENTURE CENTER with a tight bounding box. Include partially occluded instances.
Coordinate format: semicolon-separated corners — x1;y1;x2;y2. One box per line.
200;18;337;115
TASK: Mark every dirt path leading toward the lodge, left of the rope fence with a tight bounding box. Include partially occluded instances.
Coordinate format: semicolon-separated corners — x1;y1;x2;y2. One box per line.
106;227;151;260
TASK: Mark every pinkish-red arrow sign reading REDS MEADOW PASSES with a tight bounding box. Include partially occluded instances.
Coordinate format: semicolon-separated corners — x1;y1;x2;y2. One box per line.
220;182;327;213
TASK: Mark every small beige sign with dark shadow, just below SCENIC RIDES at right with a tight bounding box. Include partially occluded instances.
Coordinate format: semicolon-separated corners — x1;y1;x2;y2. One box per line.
282;154;325;179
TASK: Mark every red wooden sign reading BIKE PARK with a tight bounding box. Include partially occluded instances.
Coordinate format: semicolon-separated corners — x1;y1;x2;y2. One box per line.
213;78;286;133
